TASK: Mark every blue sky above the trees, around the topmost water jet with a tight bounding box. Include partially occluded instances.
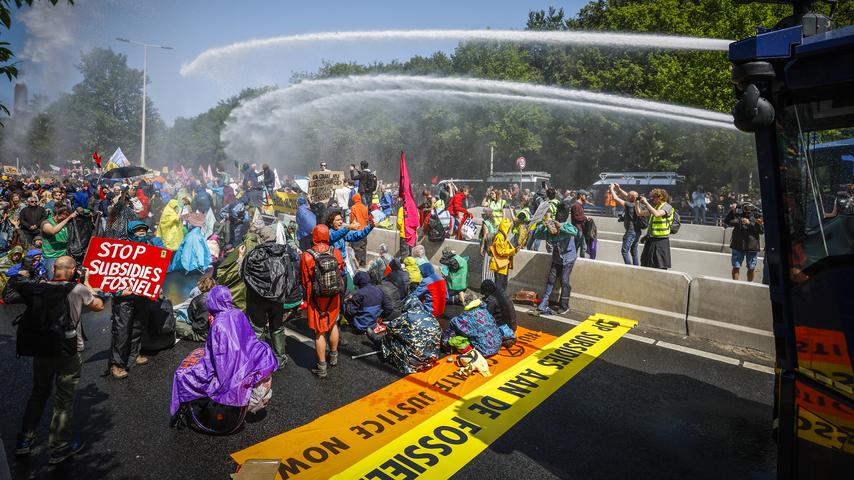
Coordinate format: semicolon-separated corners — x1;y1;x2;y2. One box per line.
0;0;585;125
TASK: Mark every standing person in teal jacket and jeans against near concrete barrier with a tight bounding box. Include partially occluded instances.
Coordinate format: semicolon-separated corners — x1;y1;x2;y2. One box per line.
531;220;578;315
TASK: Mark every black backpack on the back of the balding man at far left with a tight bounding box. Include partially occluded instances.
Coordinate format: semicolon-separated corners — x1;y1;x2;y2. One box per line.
9;277;77;357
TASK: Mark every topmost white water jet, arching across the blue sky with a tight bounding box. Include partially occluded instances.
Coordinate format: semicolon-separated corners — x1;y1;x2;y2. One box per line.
181;30;732;76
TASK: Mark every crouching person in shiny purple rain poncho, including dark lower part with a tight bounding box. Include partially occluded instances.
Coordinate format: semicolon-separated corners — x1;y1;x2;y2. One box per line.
169;285;278;434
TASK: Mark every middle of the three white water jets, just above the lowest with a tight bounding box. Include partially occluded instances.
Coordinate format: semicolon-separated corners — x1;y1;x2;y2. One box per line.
279;75;732;123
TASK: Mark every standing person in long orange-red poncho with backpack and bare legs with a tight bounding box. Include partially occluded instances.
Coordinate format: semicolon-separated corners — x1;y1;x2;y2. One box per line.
300;224;344;378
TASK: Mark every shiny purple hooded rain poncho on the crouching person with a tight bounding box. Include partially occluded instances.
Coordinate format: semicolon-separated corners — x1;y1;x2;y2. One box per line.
169;285;278;415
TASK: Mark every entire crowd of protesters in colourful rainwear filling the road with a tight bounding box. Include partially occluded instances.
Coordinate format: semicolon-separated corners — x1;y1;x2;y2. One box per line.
0;158;761;463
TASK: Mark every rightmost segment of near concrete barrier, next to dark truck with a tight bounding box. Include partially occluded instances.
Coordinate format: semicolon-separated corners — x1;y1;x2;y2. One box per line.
688;277;774;353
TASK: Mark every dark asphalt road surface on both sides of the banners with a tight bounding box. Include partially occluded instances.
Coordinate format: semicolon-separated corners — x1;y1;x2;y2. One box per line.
0;275;776;480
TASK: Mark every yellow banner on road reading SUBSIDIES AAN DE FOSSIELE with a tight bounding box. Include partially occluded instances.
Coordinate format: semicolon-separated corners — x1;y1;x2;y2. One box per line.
333;315;637;479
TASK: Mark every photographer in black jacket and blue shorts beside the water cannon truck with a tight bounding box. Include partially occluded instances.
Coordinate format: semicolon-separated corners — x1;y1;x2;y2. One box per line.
724;202;765;282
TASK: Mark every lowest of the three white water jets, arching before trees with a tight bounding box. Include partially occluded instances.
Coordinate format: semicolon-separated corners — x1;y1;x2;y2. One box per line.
234;84;735;130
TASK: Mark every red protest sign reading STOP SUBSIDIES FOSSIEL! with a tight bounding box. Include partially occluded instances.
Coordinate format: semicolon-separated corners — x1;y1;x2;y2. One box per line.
83;237;172;300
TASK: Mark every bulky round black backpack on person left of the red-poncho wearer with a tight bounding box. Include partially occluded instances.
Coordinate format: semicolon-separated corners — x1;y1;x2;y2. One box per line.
242;242;304;303
